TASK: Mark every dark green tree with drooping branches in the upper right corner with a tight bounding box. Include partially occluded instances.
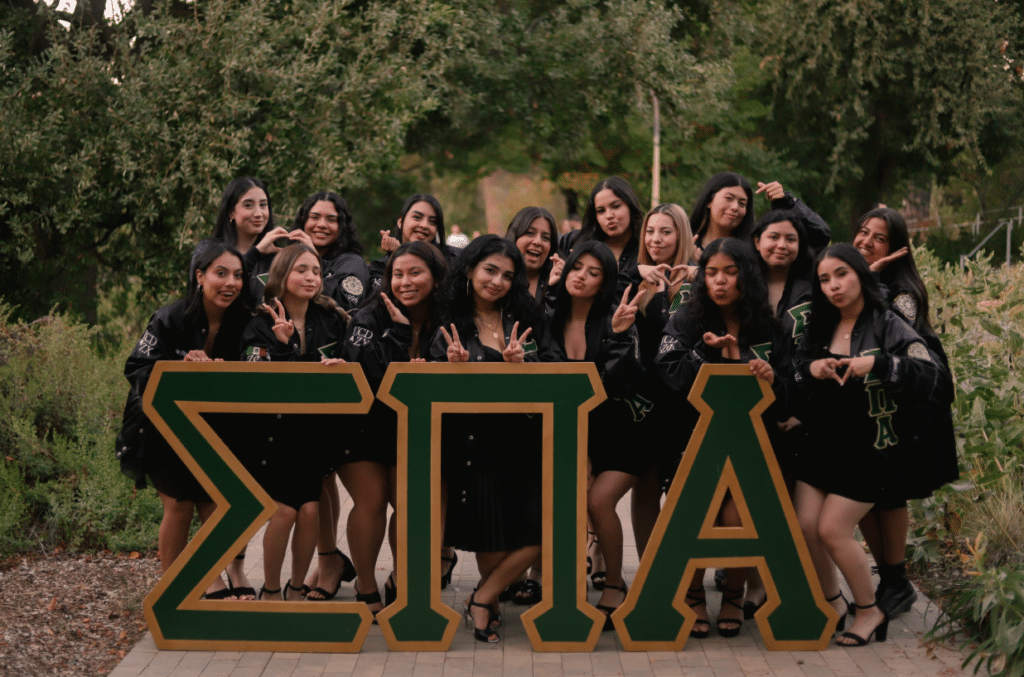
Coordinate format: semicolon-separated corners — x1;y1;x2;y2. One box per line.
761;0;1021;231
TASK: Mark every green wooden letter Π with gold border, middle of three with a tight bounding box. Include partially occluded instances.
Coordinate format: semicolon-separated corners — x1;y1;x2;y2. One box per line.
377;363;605;651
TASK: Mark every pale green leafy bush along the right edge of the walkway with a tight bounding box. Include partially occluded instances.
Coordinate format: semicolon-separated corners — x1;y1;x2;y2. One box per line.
908;249;1024;677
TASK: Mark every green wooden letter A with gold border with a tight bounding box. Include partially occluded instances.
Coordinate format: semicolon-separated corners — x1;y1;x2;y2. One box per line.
610;365;839;651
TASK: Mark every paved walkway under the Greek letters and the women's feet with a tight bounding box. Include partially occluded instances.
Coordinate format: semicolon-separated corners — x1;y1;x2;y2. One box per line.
111;491;973;677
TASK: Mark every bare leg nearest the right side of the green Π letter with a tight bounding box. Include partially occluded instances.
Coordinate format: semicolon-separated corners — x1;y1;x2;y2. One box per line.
587;470;637;606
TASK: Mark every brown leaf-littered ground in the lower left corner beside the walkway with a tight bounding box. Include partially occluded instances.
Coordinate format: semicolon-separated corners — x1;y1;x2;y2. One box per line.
0;552;160;677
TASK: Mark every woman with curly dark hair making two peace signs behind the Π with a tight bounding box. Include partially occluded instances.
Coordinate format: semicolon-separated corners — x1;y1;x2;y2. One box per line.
430;235;542;642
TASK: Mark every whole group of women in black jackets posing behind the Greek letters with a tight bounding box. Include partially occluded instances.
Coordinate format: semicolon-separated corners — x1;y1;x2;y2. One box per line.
118;172;957;645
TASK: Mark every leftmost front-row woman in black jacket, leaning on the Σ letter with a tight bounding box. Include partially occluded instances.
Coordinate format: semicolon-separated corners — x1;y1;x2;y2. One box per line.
117;241;255;599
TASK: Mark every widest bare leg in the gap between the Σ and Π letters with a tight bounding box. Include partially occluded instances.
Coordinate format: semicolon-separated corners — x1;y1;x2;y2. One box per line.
335;461;388;612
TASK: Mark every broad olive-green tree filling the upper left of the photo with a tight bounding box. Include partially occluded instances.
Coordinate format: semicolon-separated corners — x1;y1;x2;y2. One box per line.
0;0;458;320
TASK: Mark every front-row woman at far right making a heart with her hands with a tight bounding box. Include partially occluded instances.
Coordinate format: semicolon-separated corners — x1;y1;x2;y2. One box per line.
795;244;949;646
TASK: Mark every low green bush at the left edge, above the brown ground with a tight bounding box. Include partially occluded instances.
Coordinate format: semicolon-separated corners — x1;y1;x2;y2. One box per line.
0;304;161;554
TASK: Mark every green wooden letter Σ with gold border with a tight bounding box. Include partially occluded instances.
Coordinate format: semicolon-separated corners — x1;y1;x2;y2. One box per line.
143;362;373;651
